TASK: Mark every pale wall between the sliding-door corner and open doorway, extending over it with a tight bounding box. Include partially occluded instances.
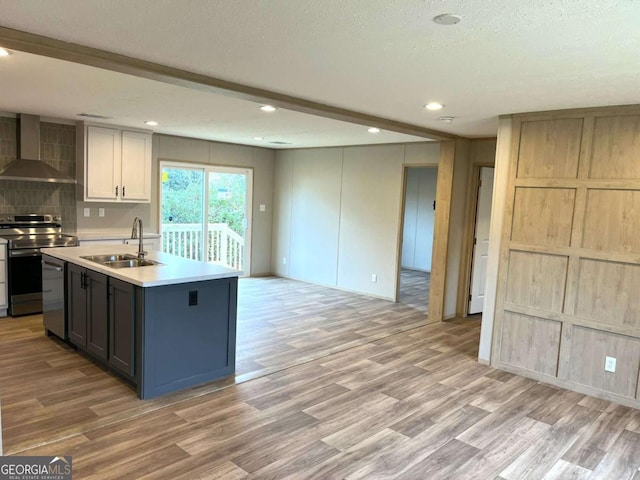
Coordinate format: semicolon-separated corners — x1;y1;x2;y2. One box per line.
272;143;440;300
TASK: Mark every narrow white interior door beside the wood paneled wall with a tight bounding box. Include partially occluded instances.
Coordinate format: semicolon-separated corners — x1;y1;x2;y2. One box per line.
468;167;494;315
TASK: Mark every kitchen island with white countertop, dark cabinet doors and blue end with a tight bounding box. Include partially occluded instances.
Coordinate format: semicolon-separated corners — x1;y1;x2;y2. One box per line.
46;245;239;399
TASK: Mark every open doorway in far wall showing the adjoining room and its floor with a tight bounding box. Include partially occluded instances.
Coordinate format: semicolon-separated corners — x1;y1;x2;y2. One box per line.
399;167;438;315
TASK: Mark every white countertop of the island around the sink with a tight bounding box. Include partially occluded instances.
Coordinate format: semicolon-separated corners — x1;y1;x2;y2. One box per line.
44;245;242;287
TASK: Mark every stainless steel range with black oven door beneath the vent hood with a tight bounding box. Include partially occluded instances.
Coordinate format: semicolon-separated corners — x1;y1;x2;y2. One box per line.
0;214;78;317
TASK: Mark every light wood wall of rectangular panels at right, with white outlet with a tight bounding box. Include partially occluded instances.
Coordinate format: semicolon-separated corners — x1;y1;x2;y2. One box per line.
492;107;640;407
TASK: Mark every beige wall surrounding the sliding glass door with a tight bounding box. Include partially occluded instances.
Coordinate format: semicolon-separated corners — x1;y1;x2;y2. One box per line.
151;134;275;275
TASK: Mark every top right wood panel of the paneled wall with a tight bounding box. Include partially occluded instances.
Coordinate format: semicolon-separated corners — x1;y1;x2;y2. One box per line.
589;115;640;179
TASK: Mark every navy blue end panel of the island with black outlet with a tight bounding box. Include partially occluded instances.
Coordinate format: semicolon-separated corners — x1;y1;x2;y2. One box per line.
138;277;238;398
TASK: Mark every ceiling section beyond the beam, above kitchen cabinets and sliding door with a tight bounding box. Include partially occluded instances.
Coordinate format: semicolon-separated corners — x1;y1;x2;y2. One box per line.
0;52;425;148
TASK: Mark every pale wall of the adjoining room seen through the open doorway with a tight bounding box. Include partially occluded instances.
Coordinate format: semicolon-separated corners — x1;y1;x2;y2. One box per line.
402;167;438;272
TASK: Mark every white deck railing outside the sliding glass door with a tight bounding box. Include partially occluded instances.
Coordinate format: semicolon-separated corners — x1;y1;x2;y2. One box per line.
162;223;244;270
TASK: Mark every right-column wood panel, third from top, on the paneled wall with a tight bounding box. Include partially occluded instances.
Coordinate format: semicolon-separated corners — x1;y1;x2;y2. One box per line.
575;258;640;329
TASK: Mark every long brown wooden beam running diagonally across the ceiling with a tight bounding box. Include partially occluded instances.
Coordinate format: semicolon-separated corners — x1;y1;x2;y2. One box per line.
0;26;457;140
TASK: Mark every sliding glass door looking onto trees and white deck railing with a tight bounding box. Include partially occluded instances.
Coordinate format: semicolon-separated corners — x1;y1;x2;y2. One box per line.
160;162;253;276
